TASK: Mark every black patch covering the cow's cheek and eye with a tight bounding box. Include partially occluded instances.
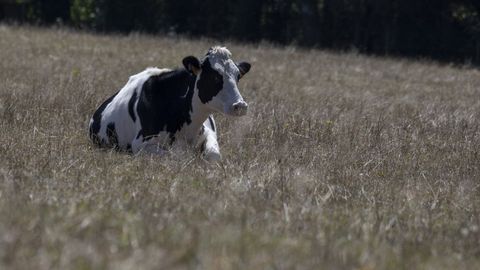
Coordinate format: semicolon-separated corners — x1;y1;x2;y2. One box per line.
197;58;223;104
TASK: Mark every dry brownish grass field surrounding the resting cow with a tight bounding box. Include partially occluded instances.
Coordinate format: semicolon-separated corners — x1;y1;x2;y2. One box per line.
0;26;480;270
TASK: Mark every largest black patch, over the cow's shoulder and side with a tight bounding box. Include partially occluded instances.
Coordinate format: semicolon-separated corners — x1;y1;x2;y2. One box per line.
137;69;196;143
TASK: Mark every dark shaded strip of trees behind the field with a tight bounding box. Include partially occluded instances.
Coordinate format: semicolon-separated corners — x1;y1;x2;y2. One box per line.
0;0;480;64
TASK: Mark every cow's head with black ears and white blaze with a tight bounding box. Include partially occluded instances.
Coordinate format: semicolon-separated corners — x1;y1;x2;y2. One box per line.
183;47;250;116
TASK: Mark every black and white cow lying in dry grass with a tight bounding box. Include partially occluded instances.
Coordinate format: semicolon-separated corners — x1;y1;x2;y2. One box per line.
89;47;250;160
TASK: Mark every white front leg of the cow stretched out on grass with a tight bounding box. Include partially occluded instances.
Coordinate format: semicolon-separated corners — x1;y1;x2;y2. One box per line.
199;116;222;161
